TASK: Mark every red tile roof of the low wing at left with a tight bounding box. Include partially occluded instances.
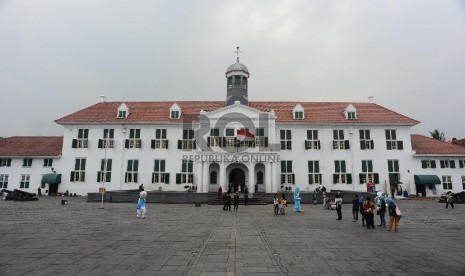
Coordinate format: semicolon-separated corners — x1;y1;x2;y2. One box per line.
0;136;63;157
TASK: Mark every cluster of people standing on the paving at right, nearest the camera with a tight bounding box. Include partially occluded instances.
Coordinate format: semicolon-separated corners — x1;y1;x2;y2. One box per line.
350;193;402;232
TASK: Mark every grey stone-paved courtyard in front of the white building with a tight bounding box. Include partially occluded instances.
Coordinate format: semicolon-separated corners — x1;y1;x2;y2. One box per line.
0;197;465;276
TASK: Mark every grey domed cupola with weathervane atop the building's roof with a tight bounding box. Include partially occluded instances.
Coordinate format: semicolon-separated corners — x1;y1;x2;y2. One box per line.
226;47;250;105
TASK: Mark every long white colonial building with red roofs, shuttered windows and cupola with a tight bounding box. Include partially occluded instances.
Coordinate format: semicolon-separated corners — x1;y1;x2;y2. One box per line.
0;60;465;196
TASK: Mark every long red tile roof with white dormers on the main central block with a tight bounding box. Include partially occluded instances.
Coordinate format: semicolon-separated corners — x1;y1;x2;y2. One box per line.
55;101;419;125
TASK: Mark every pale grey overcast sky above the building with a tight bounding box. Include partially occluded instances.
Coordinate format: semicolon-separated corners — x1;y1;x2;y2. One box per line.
0;0;465;139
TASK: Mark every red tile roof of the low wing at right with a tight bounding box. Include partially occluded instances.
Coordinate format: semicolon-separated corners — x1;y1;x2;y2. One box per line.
411;134;465;155
